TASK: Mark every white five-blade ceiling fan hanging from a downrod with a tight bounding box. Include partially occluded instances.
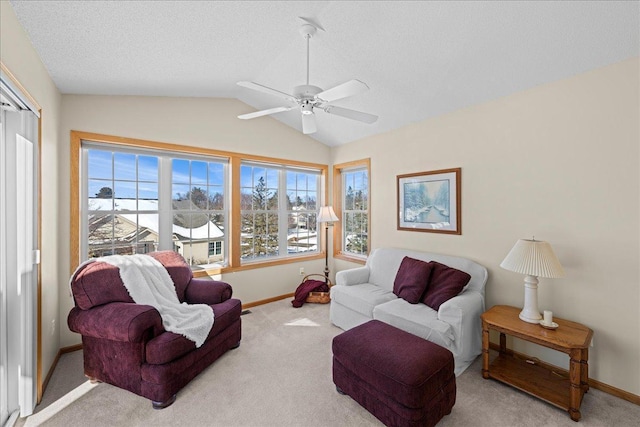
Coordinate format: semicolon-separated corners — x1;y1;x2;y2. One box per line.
238;17;378;134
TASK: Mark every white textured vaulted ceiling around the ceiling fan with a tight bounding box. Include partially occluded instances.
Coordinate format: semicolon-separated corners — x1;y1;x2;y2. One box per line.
11;0;640;146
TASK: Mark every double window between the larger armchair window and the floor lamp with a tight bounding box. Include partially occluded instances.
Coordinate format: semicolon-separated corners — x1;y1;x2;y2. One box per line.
240;162;321;262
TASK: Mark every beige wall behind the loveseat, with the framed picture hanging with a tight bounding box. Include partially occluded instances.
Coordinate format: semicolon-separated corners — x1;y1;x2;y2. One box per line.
332;58;640;395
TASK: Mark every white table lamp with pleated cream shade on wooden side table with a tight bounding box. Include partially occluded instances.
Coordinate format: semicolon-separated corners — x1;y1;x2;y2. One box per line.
500;239;564;323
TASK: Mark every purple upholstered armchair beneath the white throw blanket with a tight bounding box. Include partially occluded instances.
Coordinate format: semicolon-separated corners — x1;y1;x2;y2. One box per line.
67;251;242;409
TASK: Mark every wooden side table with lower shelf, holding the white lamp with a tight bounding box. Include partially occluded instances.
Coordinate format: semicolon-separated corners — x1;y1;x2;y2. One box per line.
481;305;593;421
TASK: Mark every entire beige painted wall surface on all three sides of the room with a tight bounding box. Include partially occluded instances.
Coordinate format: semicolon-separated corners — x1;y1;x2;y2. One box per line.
0;1;640;395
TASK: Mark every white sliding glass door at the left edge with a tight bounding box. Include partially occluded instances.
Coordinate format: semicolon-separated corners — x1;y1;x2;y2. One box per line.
0;80;39;425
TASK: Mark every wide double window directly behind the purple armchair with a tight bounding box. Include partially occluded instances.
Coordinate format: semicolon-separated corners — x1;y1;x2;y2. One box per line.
82;142;227;268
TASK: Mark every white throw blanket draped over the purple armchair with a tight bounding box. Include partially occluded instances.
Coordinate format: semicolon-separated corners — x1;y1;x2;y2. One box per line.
95;254;213;347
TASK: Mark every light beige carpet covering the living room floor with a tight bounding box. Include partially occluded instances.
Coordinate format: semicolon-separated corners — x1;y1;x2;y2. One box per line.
16;299;640;427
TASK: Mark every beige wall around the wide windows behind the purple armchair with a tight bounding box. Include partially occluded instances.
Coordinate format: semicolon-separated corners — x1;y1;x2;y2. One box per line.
58;95;331;347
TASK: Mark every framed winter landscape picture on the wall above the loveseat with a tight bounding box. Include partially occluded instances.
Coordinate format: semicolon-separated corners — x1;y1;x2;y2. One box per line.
398;168;462;234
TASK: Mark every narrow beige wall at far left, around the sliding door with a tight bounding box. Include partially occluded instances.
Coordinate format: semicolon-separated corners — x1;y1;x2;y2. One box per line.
0;1;66;394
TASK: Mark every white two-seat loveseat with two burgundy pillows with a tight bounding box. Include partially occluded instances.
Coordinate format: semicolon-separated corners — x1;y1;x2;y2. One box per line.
330;248;488;376
